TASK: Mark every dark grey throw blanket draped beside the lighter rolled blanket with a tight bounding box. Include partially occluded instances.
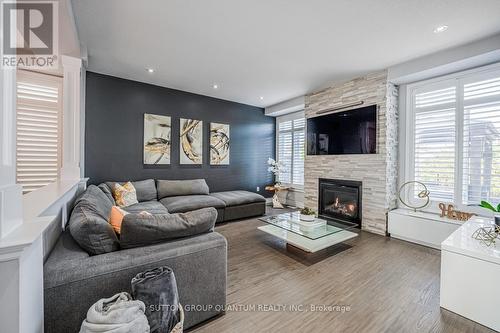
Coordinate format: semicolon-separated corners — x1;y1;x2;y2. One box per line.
132;267;180;333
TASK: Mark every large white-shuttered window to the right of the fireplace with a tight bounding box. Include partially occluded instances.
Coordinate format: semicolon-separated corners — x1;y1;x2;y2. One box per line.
408;66;500;205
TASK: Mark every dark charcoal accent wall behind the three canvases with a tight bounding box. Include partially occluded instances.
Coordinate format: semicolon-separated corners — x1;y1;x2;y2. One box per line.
85;72;275;196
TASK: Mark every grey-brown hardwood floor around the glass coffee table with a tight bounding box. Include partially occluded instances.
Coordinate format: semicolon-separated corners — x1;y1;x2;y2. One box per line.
190;210;494;333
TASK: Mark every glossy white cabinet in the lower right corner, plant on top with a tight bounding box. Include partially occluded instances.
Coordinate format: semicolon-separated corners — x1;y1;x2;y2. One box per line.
440;217;500;331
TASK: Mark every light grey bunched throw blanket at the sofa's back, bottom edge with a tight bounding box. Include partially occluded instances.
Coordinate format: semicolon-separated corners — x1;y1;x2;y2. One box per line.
80;293;149;333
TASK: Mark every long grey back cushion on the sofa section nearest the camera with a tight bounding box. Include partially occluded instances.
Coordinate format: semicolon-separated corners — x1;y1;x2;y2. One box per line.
120;207;217;249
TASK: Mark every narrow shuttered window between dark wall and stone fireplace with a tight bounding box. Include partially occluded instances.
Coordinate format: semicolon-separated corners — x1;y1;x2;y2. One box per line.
276;112;306;187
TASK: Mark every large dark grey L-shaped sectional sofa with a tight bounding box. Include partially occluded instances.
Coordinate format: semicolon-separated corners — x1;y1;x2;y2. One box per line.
44;179;265;333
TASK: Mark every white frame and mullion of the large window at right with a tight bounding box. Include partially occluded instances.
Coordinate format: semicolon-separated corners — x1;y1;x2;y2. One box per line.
402;63;500;215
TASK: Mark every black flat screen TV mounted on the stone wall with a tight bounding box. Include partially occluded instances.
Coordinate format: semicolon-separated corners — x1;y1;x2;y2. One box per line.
307;105;377;155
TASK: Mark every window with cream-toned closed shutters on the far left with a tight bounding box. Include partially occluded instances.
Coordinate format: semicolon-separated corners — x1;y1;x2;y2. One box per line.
16;70;62;193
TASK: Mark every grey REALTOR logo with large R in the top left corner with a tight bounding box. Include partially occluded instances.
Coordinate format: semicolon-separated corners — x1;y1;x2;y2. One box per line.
1;1;59;69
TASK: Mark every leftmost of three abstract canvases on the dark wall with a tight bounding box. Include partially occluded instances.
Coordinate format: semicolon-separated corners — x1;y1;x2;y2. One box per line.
144;113;172;164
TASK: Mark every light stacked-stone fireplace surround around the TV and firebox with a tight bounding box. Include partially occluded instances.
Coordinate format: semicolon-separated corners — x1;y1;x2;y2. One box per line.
304;70;398;235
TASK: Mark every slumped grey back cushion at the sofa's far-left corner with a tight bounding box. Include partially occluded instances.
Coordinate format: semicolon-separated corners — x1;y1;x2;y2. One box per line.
69;185;119;254
